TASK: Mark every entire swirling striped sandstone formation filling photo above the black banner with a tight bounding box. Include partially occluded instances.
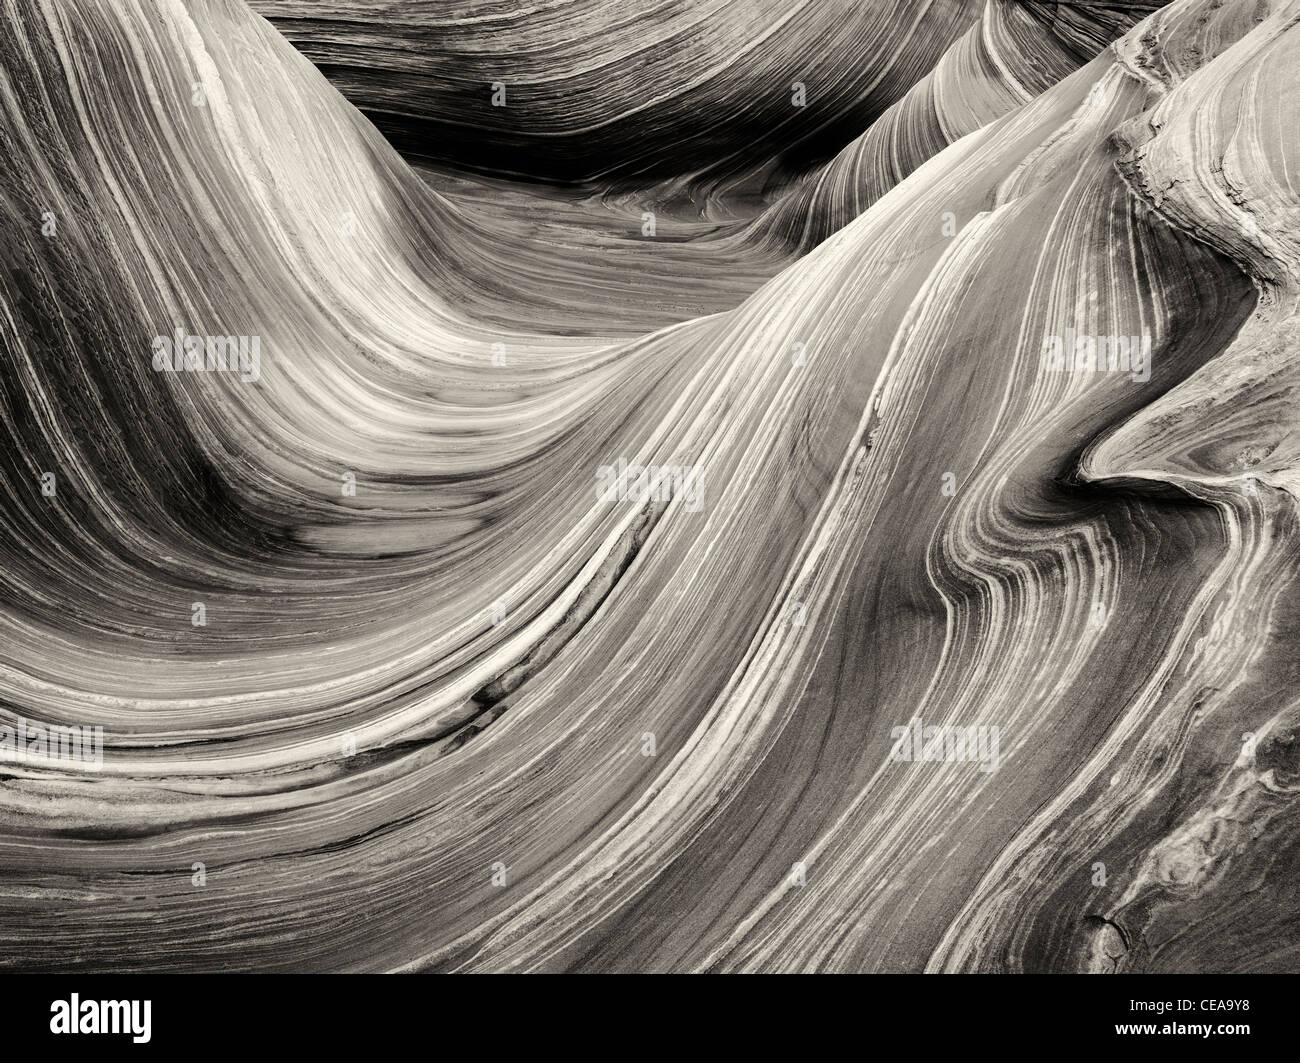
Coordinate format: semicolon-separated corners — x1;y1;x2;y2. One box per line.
0;0;1300;971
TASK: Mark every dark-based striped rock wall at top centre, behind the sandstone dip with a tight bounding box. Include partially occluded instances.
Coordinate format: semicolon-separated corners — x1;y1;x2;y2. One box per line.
245;0;977;188
